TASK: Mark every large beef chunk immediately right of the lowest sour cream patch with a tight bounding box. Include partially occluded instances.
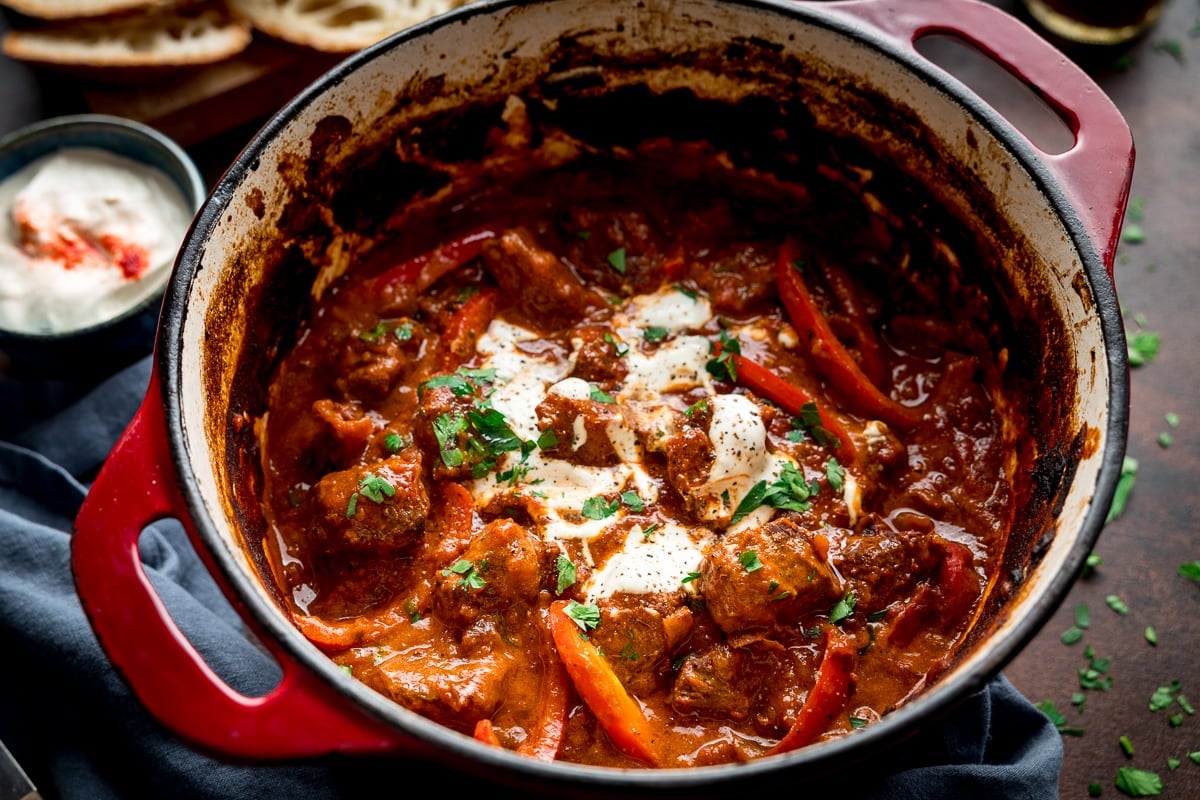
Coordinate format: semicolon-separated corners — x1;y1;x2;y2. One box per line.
698;517;842;632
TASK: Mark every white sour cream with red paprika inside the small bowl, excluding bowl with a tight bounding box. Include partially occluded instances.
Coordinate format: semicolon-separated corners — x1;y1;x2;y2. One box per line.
0;148;192;333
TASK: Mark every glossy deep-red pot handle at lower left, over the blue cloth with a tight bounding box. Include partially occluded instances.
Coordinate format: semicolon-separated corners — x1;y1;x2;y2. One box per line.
71;369;418;759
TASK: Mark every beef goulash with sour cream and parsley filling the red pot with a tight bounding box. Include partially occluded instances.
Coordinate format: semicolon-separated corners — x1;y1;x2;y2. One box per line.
256;97;1018;768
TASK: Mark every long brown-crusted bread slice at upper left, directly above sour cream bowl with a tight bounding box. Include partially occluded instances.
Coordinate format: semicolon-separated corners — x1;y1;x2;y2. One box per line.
4;4;252;70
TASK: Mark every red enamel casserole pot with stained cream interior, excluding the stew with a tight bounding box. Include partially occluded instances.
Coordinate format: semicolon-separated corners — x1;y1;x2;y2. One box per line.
72;0;1133;794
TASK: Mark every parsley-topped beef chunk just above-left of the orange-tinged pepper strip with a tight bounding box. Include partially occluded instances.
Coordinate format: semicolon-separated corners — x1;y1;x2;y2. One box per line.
433;519;548;627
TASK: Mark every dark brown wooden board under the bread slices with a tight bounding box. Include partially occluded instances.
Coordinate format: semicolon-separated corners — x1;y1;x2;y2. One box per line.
83;37;346;148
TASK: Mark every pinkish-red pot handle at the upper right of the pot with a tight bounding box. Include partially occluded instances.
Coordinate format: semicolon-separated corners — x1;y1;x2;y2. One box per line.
821;0;1134;278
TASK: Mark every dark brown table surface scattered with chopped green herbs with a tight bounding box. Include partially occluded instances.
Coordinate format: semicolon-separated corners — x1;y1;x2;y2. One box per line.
0;0;1200;800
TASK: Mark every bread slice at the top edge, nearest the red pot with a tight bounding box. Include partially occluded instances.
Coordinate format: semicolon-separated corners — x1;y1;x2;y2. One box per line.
229;0;467;53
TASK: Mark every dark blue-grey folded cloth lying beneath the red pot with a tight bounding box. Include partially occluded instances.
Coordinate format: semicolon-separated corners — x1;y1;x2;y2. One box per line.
0;357;1062;800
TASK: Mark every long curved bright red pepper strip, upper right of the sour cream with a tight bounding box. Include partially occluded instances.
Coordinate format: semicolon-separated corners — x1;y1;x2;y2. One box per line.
775;239;922;429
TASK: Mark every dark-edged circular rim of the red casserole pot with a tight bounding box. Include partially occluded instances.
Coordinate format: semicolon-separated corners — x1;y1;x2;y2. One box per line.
156;0;1129;792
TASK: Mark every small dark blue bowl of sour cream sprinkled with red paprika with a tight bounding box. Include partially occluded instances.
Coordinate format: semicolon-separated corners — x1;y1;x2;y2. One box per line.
0;114;206;371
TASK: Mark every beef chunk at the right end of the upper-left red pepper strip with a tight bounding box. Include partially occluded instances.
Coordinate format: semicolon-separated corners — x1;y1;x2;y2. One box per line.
484;228;606;331
